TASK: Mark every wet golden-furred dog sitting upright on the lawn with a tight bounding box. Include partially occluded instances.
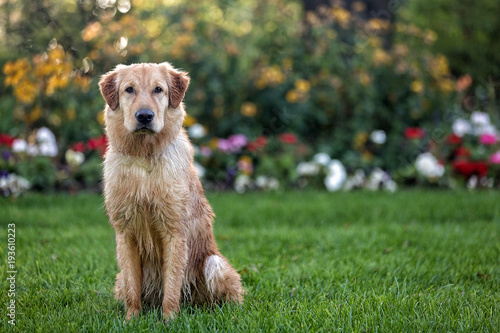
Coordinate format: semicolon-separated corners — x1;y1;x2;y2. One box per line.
99;62;244;320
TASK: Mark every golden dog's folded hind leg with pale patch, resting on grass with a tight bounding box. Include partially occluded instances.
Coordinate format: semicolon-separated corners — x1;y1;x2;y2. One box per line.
203;254;243;303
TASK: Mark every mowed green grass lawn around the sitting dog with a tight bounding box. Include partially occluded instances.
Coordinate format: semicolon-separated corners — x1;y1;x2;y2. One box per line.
0;191;500;332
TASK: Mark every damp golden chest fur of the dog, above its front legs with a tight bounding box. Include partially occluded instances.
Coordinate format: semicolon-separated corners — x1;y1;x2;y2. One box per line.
104;135;190;232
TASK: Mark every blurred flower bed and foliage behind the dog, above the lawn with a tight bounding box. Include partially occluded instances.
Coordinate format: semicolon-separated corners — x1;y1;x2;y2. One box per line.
0;0;500;196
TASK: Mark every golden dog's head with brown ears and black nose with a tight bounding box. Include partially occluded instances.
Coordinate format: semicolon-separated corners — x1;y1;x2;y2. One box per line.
99;63;189;135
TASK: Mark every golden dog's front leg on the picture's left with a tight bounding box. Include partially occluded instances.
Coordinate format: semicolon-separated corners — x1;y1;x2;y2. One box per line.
116;232;142;320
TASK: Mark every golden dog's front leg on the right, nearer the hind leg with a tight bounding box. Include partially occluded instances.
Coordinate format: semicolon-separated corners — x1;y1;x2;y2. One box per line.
162;232;188;319
